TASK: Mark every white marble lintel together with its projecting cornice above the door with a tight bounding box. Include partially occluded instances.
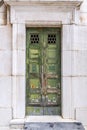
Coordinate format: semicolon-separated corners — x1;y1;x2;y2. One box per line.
4;0;83;24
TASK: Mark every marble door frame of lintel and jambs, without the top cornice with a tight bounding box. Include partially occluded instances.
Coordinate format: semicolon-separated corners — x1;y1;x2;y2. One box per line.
11;3;78;124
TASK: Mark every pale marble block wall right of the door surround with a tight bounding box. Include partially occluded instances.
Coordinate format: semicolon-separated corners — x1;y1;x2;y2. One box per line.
72;0;87;125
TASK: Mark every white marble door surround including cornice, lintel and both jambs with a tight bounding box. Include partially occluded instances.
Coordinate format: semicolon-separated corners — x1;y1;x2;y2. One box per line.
5;0;82;123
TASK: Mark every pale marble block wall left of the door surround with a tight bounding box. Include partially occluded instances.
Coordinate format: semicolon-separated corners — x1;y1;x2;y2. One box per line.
0;25;12;130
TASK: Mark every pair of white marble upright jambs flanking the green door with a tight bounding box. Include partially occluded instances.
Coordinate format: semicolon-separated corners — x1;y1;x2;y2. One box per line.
12;23;74;119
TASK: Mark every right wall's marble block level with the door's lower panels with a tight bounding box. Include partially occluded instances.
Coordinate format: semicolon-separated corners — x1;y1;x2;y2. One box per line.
72;77;87;107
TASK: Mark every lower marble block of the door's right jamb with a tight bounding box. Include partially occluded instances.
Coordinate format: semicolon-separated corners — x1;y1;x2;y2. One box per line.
62;77;72;119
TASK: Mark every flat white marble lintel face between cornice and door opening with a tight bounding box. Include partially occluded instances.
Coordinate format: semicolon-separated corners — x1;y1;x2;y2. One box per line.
11;1;73;25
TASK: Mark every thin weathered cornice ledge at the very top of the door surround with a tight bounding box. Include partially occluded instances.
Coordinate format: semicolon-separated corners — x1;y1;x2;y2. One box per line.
4;0;84;7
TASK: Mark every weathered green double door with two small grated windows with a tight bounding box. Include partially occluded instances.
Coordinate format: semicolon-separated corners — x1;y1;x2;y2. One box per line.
26;28;61;115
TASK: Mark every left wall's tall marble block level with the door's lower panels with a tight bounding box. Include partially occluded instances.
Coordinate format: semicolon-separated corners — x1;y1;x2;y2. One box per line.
0;76;12;107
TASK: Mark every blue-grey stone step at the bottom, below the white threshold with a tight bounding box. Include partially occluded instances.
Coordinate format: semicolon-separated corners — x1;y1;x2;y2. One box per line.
24;123;84;130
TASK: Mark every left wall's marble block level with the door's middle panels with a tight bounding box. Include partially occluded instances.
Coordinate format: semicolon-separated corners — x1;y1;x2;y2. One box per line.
0;51;12;76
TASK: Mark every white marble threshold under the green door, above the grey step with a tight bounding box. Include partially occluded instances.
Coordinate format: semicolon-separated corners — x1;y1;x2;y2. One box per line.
10;115;78;129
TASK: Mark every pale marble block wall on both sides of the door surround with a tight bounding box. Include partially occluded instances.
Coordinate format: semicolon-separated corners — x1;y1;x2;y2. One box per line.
0;0;87;130
